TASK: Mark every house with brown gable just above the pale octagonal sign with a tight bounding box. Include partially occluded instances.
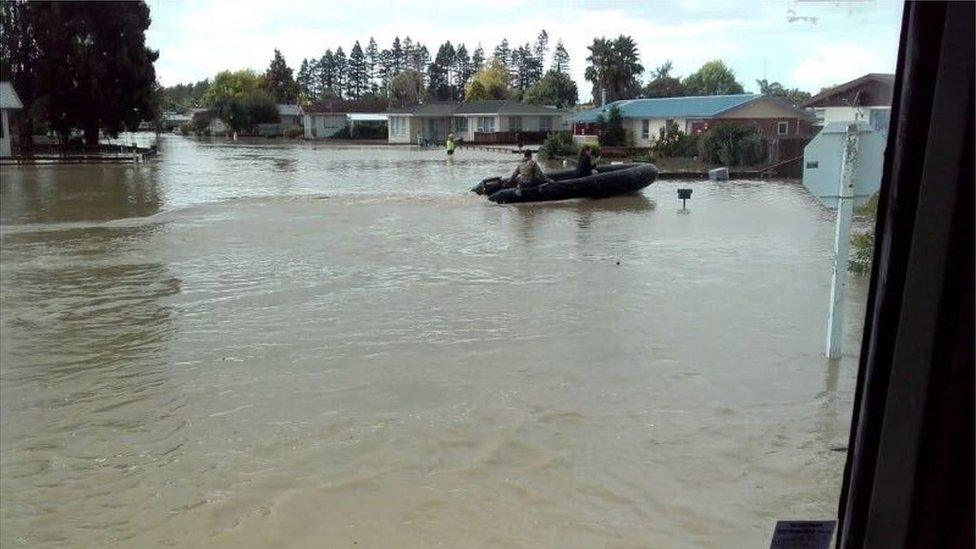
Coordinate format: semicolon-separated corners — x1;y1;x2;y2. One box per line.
800;73;895;134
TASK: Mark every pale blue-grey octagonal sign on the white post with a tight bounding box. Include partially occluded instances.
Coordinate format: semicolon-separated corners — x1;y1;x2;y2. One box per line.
803;121;887;208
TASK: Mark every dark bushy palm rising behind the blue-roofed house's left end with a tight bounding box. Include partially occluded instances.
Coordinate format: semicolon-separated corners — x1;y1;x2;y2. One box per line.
585;35;644;103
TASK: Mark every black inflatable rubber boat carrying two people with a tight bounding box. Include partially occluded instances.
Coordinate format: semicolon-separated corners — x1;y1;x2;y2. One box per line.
471;164;657;204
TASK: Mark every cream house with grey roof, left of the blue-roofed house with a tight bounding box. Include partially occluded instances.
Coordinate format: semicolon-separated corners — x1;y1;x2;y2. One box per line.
388;99;565;143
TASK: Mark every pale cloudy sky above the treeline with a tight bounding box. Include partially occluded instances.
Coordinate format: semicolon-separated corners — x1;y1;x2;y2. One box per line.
147;0;902;101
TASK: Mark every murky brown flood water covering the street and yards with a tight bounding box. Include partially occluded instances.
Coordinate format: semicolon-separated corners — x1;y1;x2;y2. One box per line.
0;136;866;547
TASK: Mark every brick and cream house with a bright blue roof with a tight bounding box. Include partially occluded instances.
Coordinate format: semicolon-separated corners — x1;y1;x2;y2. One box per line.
569;94;813;147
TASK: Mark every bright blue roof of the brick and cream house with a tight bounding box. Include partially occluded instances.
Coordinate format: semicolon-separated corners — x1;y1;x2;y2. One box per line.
569;93;763;123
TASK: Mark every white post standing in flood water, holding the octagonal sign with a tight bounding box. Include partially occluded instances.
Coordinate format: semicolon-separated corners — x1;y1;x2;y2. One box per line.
827;122;860;359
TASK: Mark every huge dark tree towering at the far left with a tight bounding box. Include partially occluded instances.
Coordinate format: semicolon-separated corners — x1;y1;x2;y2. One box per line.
20;1;159;145
